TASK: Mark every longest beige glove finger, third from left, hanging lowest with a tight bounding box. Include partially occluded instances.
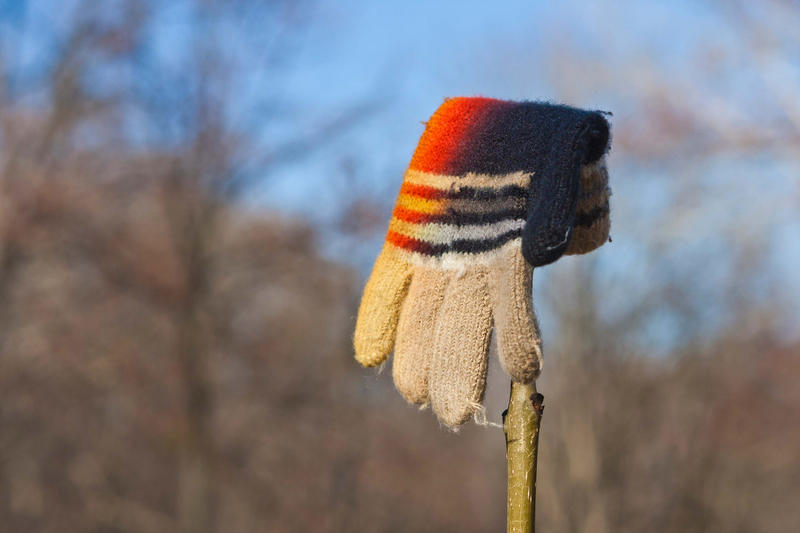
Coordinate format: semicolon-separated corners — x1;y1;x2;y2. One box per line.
430;267;492;427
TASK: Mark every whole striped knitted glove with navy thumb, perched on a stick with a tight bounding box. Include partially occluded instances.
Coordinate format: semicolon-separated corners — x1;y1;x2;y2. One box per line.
354;98;610;427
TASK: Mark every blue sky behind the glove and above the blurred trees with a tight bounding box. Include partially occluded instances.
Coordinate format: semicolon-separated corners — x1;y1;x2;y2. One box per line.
0;0;800;348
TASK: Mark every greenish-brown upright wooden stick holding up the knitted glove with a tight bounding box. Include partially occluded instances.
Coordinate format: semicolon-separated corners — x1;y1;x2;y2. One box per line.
503;382;544;533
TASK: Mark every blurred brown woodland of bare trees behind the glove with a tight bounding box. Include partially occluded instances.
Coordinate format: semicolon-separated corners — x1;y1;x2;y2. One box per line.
0;1;800;533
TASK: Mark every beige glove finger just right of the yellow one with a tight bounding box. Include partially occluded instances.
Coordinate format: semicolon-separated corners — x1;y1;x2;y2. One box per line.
392;268;448;404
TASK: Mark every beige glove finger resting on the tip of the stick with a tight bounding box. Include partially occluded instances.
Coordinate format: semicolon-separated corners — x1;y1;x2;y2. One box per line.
489;248;542;383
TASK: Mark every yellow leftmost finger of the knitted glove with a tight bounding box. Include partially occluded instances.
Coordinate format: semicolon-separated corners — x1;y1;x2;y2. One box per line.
353;246;412;366
